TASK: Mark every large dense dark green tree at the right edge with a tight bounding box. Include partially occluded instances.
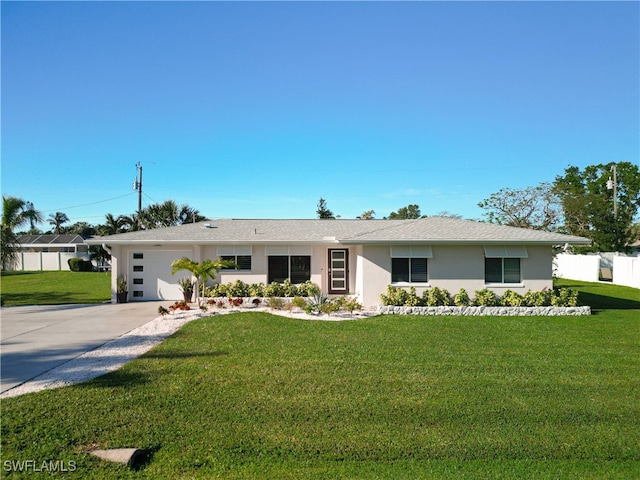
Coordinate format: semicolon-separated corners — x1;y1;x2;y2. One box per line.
553;162;640;252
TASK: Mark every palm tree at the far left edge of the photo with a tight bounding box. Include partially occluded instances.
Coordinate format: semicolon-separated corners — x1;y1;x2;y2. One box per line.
0;195;42;270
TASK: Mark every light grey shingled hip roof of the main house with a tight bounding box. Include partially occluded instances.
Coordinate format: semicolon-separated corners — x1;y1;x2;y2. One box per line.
85;217;591;245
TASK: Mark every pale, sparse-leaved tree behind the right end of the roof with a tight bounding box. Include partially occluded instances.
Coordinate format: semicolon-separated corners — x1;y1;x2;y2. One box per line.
478;183;562;231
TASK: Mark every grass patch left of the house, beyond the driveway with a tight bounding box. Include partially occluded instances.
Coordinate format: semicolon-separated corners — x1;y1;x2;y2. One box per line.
0;272;111;306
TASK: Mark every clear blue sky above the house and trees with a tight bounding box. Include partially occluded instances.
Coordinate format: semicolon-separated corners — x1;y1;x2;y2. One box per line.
1;1;640;229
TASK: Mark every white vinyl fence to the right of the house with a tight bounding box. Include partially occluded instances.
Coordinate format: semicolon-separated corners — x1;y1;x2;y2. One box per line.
554;253;640;288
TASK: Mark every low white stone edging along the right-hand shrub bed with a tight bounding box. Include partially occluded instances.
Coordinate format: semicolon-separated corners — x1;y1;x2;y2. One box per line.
378;305;591;317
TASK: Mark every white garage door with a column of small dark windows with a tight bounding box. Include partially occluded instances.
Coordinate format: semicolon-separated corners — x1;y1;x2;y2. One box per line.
129;250;192;301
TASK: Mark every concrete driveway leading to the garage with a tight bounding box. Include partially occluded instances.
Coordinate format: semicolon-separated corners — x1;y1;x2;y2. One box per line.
0;302;165;392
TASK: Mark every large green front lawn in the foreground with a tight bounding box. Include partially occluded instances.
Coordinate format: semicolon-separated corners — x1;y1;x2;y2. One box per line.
2;282;640;479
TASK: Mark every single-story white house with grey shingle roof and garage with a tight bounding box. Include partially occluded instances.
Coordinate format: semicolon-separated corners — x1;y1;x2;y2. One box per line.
87;217;590;307
